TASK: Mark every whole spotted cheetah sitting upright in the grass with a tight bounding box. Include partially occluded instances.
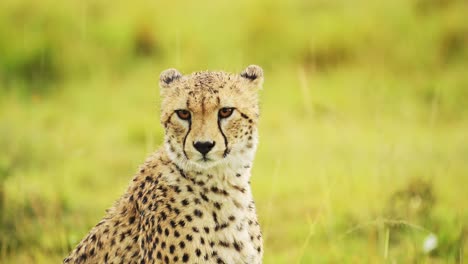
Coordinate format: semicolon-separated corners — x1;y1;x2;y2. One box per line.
63;65;263;264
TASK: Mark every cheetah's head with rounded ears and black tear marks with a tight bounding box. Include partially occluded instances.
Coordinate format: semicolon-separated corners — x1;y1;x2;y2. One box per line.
160;65;263;169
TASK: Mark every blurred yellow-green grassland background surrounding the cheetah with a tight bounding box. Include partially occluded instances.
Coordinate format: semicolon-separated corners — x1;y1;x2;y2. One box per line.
0;0;468;263
